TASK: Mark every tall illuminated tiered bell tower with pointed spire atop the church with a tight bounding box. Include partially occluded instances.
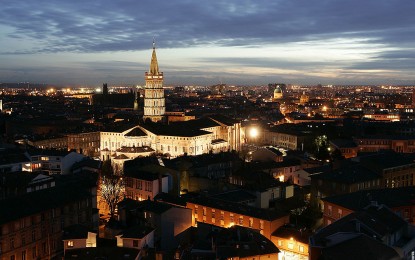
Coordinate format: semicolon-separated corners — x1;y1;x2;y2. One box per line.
143;41;166;122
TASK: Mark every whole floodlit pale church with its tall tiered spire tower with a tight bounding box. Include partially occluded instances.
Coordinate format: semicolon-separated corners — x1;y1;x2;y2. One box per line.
100;43;241;163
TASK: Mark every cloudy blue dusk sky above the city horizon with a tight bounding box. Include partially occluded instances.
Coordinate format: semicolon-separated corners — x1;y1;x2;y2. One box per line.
0;0;415;86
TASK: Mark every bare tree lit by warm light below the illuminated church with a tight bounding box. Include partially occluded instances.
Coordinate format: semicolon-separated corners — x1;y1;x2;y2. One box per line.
100;161;125;218
